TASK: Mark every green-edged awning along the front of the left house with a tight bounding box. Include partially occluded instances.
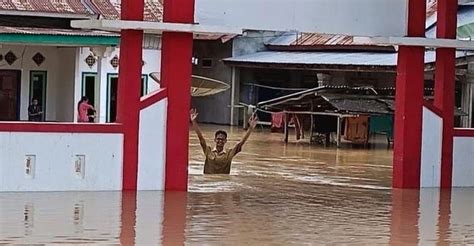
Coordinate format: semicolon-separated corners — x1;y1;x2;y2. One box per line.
0;26;120;46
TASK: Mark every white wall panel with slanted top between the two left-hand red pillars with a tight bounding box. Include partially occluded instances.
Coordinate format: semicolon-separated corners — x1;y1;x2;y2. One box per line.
138;99;168;190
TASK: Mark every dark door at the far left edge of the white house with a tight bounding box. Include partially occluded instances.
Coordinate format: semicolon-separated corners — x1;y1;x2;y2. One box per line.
0;70;21;121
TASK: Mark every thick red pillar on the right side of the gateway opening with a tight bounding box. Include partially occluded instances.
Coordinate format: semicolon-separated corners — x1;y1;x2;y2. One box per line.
393;0;426;188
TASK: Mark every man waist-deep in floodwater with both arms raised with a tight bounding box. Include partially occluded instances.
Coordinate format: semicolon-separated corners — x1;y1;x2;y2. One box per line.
190;109;257;174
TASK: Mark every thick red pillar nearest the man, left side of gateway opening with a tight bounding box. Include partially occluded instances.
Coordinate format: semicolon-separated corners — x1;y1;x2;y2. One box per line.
161;0;194;191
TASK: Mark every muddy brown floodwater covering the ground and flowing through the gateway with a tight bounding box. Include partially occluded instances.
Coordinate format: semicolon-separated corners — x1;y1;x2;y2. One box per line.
0;126;474;245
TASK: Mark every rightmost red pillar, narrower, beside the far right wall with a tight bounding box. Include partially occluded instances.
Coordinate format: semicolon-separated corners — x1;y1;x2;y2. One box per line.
434;0;458;188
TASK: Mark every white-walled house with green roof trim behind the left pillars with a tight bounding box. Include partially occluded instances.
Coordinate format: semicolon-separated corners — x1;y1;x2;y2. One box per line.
0;0;162;122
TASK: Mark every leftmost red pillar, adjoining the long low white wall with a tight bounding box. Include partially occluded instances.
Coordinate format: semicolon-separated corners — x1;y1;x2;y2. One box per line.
117;0;144;190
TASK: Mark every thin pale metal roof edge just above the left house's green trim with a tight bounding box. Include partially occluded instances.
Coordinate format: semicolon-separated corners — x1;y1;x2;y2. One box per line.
0;26;120;37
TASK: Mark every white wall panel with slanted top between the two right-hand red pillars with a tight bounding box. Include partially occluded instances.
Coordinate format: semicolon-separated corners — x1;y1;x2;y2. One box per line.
420;107;443;187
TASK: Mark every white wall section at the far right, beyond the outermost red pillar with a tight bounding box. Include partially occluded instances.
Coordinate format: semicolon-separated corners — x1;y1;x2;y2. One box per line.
453;137;474;187
